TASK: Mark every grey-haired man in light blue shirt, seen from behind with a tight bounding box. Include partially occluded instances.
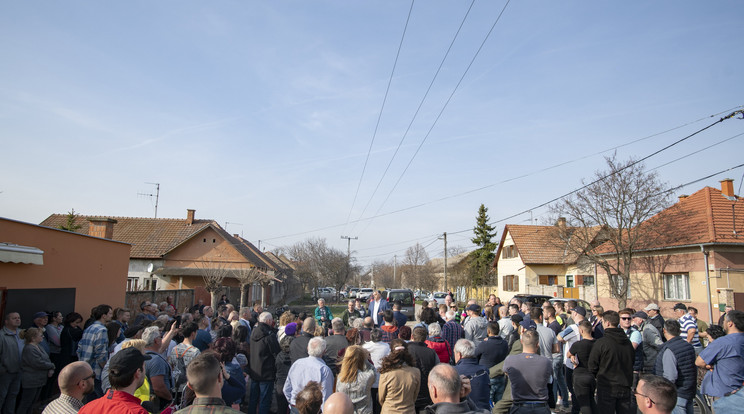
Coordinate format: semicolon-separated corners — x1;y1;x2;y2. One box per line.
284;337;333;406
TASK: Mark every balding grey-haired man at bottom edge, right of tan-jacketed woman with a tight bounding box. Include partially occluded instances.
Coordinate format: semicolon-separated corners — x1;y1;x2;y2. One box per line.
425;364;490;414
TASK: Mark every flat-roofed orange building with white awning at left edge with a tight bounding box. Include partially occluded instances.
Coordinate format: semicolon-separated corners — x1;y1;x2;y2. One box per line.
0;217;131;327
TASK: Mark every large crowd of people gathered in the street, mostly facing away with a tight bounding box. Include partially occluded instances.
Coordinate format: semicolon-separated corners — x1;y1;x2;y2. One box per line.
0;291;744;414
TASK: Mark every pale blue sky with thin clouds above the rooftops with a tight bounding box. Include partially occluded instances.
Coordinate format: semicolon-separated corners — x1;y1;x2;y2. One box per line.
0;0;744;263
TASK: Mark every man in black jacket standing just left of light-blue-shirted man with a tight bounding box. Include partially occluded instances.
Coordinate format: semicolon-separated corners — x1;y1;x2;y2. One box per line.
248;312;279;413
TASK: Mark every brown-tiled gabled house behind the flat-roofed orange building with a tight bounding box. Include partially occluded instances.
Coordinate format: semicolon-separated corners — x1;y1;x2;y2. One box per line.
42;210;284;305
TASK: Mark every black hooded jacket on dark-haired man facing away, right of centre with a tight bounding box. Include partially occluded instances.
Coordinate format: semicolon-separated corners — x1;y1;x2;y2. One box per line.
589;328;635;389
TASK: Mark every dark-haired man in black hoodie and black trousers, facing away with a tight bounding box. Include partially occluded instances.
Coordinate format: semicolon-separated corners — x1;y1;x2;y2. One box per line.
589;311;635;414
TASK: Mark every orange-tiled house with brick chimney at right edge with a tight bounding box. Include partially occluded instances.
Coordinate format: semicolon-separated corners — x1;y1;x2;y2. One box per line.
597;179;744;322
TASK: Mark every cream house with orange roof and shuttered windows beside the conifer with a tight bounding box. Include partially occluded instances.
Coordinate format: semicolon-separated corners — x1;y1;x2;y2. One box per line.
493;222;600;301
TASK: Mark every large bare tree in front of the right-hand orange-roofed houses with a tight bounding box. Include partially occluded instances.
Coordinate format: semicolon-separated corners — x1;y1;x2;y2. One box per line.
551;155;672;309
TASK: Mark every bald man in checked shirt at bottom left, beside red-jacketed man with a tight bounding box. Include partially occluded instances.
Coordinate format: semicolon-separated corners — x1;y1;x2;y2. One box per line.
42;361;95;414
